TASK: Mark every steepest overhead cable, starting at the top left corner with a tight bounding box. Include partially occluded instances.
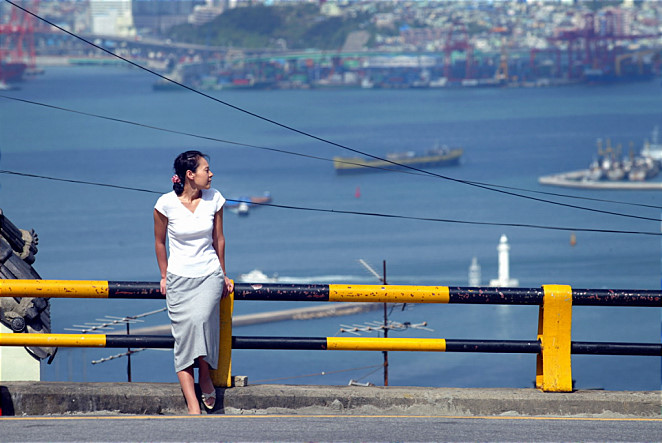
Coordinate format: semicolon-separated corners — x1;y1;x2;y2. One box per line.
5;0;657;221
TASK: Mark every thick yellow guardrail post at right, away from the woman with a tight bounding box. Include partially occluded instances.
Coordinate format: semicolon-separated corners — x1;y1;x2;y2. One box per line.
536;285;572;392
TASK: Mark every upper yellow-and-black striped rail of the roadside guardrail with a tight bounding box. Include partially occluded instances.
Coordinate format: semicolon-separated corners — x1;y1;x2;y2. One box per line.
0;280;662;307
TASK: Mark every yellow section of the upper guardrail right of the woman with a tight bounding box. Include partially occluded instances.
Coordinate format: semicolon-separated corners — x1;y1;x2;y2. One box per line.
329;285;450;303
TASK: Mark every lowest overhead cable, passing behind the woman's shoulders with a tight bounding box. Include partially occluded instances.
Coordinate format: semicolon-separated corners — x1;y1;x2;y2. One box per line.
0;170;662;236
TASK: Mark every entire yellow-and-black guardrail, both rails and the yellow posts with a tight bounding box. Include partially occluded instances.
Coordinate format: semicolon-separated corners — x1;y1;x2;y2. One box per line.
0;280;662;392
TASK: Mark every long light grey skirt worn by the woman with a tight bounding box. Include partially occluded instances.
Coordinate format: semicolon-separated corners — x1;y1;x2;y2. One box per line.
166;267;225;372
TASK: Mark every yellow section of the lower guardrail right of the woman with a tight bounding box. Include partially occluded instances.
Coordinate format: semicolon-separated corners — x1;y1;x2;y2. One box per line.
326;337;446;352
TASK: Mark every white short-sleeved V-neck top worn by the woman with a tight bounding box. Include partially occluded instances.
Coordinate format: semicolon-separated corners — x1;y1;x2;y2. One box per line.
154;188;225;278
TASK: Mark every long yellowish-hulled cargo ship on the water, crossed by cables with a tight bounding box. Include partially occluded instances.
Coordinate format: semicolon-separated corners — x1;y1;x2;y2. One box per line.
333;146;463;174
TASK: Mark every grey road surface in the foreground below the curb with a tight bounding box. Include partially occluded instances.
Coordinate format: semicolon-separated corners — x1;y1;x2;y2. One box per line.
0;415;662;442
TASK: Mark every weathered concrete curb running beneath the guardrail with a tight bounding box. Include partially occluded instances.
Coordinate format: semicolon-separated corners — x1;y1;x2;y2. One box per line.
0;382;662;418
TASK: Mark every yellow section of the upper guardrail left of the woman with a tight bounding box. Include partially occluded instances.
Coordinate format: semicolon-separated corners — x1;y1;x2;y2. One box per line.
0;280;109;298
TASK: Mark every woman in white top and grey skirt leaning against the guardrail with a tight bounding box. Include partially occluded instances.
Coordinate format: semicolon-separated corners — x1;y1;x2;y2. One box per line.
154;151;234;414
